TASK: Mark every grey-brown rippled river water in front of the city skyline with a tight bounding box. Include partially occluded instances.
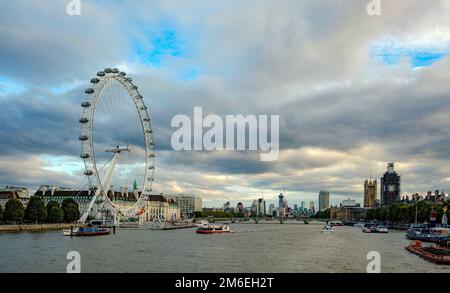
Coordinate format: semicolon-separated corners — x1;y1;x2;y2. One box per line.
0;222;450;273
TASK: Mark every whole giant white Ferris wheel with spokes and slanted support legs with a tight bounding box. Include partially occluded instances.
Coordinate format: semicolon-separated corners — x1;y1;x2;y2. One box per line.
79;68;155;222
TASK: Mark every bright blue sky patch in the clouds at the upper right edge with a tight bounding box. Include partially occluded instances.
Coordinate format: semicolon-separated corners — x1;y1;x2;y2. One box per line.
371;44;450;68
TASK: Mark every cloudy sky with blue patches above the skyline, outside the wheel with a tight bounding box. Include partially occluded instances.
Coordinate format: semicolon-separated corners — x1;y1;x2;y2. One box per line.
0;0;450;206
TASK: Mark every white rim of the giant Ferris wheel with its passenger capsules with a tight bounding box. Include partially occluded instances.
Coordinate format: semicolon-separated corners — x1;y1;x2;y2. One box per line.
80;68;155;214
